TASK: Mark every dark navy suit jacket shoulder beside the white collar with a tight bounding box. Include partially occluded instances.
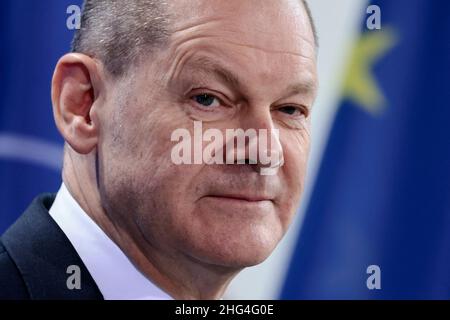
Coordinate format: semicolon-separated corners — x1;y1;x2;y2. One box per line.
0;194;103;300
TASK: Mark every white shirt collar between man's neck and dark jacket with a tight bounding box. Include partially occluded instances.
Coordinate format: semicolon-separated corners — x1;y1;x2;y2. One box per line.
49;183;172;300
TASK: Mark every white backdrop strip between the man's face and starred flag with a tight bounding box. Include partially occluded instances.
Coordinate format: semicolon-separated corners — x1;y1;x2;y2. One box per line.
225;0;367;299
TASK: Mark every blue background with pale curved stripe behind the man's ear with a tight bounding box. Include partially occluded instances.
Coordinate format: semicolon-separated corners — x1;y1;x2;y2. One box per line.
0;0;81;234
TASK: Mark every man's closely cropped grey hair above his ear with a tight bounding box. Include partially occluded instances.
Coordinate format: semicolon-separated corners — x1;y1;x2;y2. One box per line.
71;0;317;77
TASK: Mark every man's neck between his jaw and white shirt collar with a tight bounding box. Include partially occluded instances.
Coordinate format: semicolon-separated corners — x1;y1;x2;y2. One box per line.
63;147;240;299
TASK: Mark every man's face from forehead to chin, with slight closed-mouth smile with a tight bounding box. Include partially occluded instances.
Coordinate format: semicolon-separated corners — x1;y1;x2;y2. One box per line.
98;0;316;268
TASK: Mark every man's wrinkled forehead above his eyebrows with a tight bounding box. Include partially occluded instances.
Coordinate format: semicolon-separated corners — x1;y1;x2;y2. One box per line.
162;0;316;92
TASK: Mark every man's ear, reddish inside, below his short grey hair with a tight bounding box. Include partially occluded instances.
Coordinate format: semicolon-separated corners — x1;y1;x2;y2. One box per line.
52;53;101;154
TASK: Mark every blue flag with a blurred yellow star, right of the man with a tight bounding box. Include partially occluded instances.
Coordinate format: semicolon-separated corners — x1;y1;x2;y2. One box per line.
281;0;450;299
